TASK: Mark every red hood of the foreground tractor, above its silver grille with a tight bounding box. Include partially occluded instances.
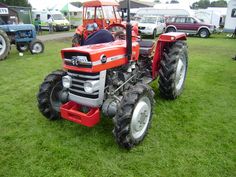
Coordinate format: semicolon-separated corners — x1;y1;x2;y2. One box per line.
61;40;139;72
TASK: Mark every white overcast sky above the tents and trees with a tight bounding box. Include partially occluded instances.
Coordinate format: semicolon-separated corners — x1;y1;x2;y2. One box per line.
28;0;200;9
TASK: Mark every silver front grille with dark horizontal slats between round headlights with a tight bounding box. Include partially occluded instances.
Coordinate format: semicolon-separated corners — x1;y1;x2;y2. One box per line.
68;71;100;99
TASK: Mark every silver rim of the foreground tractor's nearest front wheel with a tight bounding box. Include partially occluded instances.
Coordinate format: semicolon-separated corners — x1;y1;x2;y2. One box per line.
130;96;151;139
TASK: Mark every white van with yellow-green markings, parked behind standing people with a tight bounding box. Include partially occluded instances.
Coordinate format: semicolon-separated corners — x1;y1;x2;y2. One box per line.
32;10;70;31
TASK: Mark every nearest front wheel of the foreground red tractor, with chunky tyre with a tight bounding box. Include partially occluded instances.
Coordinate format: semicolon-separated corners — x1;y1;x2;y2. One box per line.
113;84;154;149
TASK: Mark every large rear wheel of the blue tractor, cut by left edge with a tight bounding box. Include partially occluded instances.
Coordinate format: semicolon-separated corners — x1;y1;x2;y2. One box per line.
0;30;11;60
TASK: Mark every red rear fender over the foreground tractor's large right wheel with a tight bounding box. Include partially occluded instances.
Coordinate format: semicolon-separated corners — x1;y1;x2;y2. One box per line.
152;32;187;79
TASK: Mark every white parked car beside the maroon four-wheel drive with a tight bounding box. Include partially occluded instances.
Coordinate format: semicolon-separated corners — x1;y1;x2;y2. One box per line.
138;16;166;38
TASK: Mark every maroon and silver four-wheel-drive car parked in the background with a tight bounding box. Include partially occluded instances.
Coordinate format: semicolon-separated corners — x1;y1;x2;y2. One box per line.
166;16;216;38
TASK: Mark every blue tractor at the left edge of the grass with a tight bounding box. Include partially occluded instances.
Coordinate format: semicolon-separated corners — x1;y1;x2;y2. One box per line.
0;24;44;60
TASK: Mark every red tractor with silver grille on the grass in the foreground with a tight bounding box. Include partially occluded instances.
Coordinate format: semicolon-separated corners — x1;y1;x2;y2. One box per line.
37;1;188;149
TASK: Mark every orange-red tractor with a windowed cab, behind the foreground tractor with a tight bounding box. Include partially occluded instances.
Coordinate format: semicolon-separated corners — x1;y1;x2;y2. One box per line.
72;0;131;47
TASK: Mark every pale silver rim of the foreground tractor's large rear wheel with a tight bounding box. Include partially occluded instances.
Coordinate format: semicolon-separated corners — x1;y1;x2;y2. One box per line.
175;56;186;91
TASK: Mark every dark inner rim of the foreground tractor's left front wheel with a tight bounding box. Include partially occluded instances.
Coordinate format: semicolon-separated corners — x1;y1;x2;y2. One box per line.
50;82;63;112
